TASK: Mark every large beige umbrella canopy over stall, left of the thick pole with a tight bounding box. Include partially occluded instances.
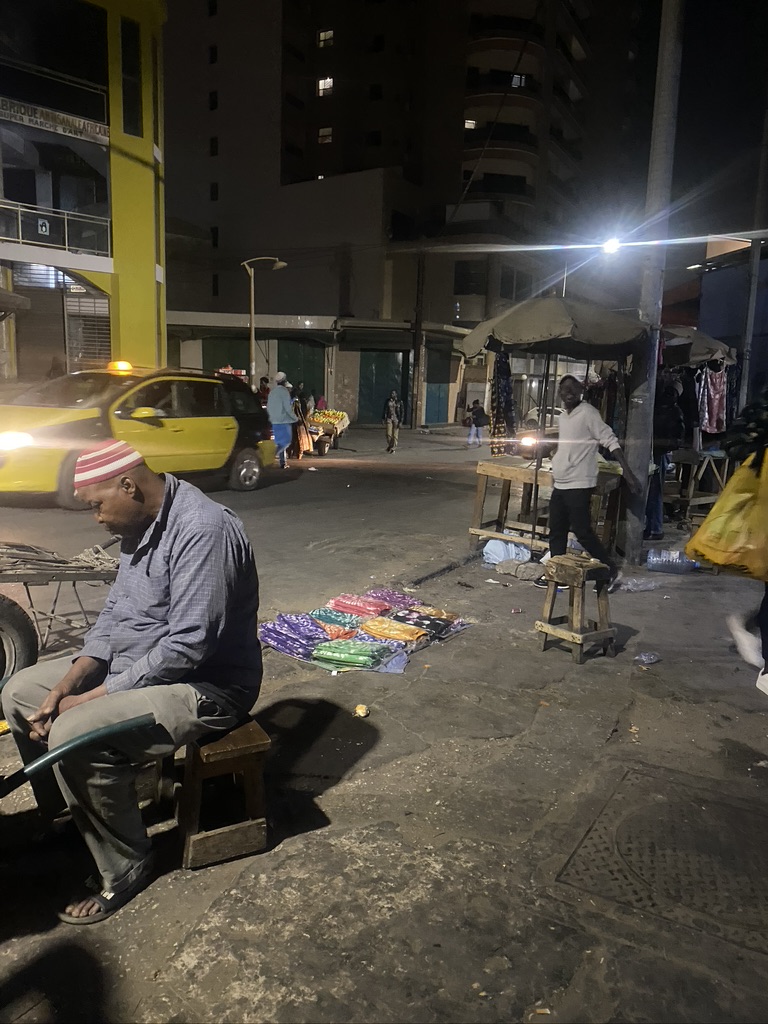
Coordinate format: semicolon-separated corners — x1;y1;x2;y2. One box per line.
455;296;647;359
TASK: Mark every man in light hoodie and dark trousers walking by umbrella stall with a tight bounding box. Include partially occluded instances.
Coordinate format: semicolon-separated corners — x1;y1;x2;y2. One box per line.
537;376;641;588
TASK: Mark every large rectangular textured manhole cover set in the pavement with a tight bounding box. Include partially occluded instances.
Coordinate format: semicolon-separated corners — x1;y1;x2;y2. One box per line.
558;771;768;953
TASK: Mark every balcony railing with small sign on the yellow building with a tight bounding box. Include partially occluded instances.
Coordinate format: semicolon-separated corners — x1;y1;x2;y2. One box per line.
0;200;112;257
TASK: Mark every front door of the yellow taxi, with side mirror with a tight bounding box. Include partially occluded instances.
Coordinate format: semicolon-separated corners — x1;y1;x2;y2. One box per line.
110;378;183;473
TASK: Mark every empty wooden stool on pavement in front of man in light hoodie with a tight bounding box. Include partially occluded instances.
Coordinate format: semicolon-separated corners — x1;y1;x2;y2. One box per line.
535;555;616;665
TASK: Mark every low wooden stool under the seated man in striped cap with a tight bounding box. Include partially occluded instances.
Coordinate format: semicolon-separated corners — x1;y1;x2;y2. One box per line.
178;721;271;867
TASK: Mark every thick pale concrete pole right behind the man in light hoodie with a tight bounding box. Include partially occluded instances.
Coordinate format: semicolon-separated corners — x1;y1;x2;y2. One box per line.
626;0;684;565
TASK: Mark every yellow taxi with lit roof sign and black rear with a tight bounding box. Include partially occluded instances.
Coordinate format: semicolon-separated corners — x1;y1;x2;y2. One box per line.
0;361;274;508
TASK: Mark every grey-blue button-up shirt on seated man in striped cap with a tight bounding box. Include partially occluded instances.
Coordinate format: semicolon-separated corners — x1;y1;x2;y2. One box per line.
80;473;262;714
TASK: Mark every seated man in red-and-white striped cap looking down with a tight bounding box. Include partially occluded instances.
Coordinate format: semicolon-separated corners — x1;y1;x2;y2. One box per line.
2;440;262;925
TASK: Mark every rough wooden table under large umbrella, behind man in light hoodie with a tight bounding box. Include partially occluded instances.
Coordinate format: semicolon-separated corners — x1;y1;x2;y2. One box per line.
469;456;622;551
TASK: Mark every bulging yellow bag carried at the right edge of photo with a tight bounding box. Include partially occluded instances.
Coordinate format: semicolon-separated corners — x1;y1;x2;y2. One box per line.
685;453;768;583
